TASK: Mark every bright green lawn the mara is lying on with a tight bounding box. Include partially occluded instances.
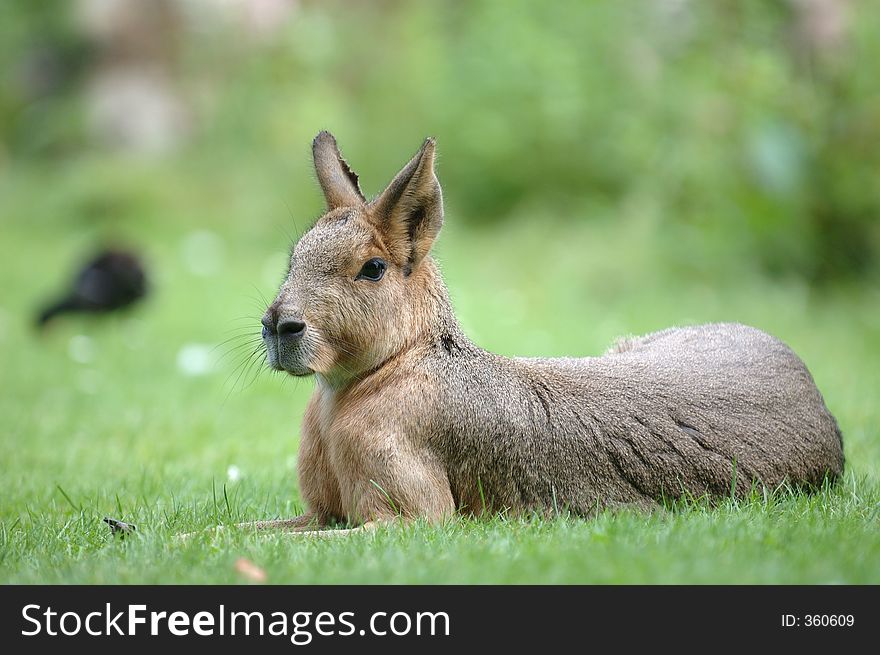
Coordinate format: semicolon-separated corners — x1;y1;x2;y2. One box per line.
0;159;880;583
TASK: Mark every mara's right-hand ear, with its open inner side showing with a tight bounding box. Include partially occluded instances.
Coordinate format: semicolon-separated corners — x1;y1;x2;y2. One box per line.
370;138;443;275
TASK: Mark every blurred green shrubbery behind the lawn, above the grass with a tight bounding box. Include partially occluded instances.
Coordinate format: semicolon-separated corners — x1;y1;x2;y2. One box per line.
0;0;880;283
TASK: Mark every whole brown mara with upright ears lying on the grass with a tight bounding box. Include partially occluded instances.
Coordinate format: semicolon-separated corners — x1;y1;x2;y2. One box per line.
257;132;843;529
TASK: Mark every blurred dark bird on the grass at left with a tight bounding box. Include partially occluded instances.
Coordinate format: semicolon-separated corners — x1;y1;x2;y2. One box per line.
37;250;147;327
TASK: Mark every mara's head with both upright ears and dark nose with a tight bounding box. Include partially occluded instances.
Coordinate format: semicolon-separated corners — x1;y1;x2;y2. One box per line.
262;132;443;380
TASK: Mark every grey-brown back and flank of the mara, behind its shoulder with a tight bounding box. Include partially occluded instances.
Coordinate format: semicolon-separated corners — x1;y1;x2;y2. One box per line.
430;324;843;514
